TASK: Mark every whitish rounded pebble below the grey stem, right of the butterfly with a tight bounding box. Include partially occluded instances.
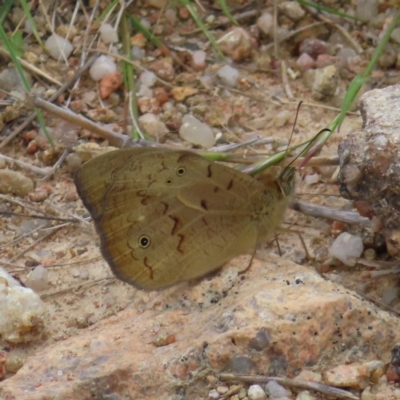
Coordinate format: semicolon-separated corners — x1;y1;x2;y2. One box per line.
329;232;364;267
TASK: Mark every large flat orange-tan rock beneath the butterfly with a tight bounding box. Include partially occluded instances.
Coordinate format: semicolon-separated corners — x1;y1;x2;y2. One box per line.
0;254;400;400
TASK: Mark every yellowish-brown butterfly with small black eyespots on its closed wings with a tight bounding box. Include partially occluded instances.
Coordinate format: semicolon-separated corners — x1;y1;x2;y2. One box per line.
75;148;288;290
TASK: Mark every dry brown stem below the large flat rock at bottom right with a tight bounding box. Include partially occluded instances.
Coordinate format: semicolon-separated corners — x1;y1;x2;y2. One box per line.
219;374;360;400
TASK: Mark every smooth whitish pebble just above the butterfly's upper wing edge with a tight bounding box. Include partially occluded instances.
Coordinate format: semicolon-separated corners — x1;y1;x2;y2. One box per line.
179;114;215;149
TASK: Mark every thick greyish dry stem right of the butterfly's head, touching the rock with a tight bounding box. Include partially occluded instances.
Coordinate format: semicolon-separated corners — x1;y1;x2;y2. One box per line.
289;200;369;224
